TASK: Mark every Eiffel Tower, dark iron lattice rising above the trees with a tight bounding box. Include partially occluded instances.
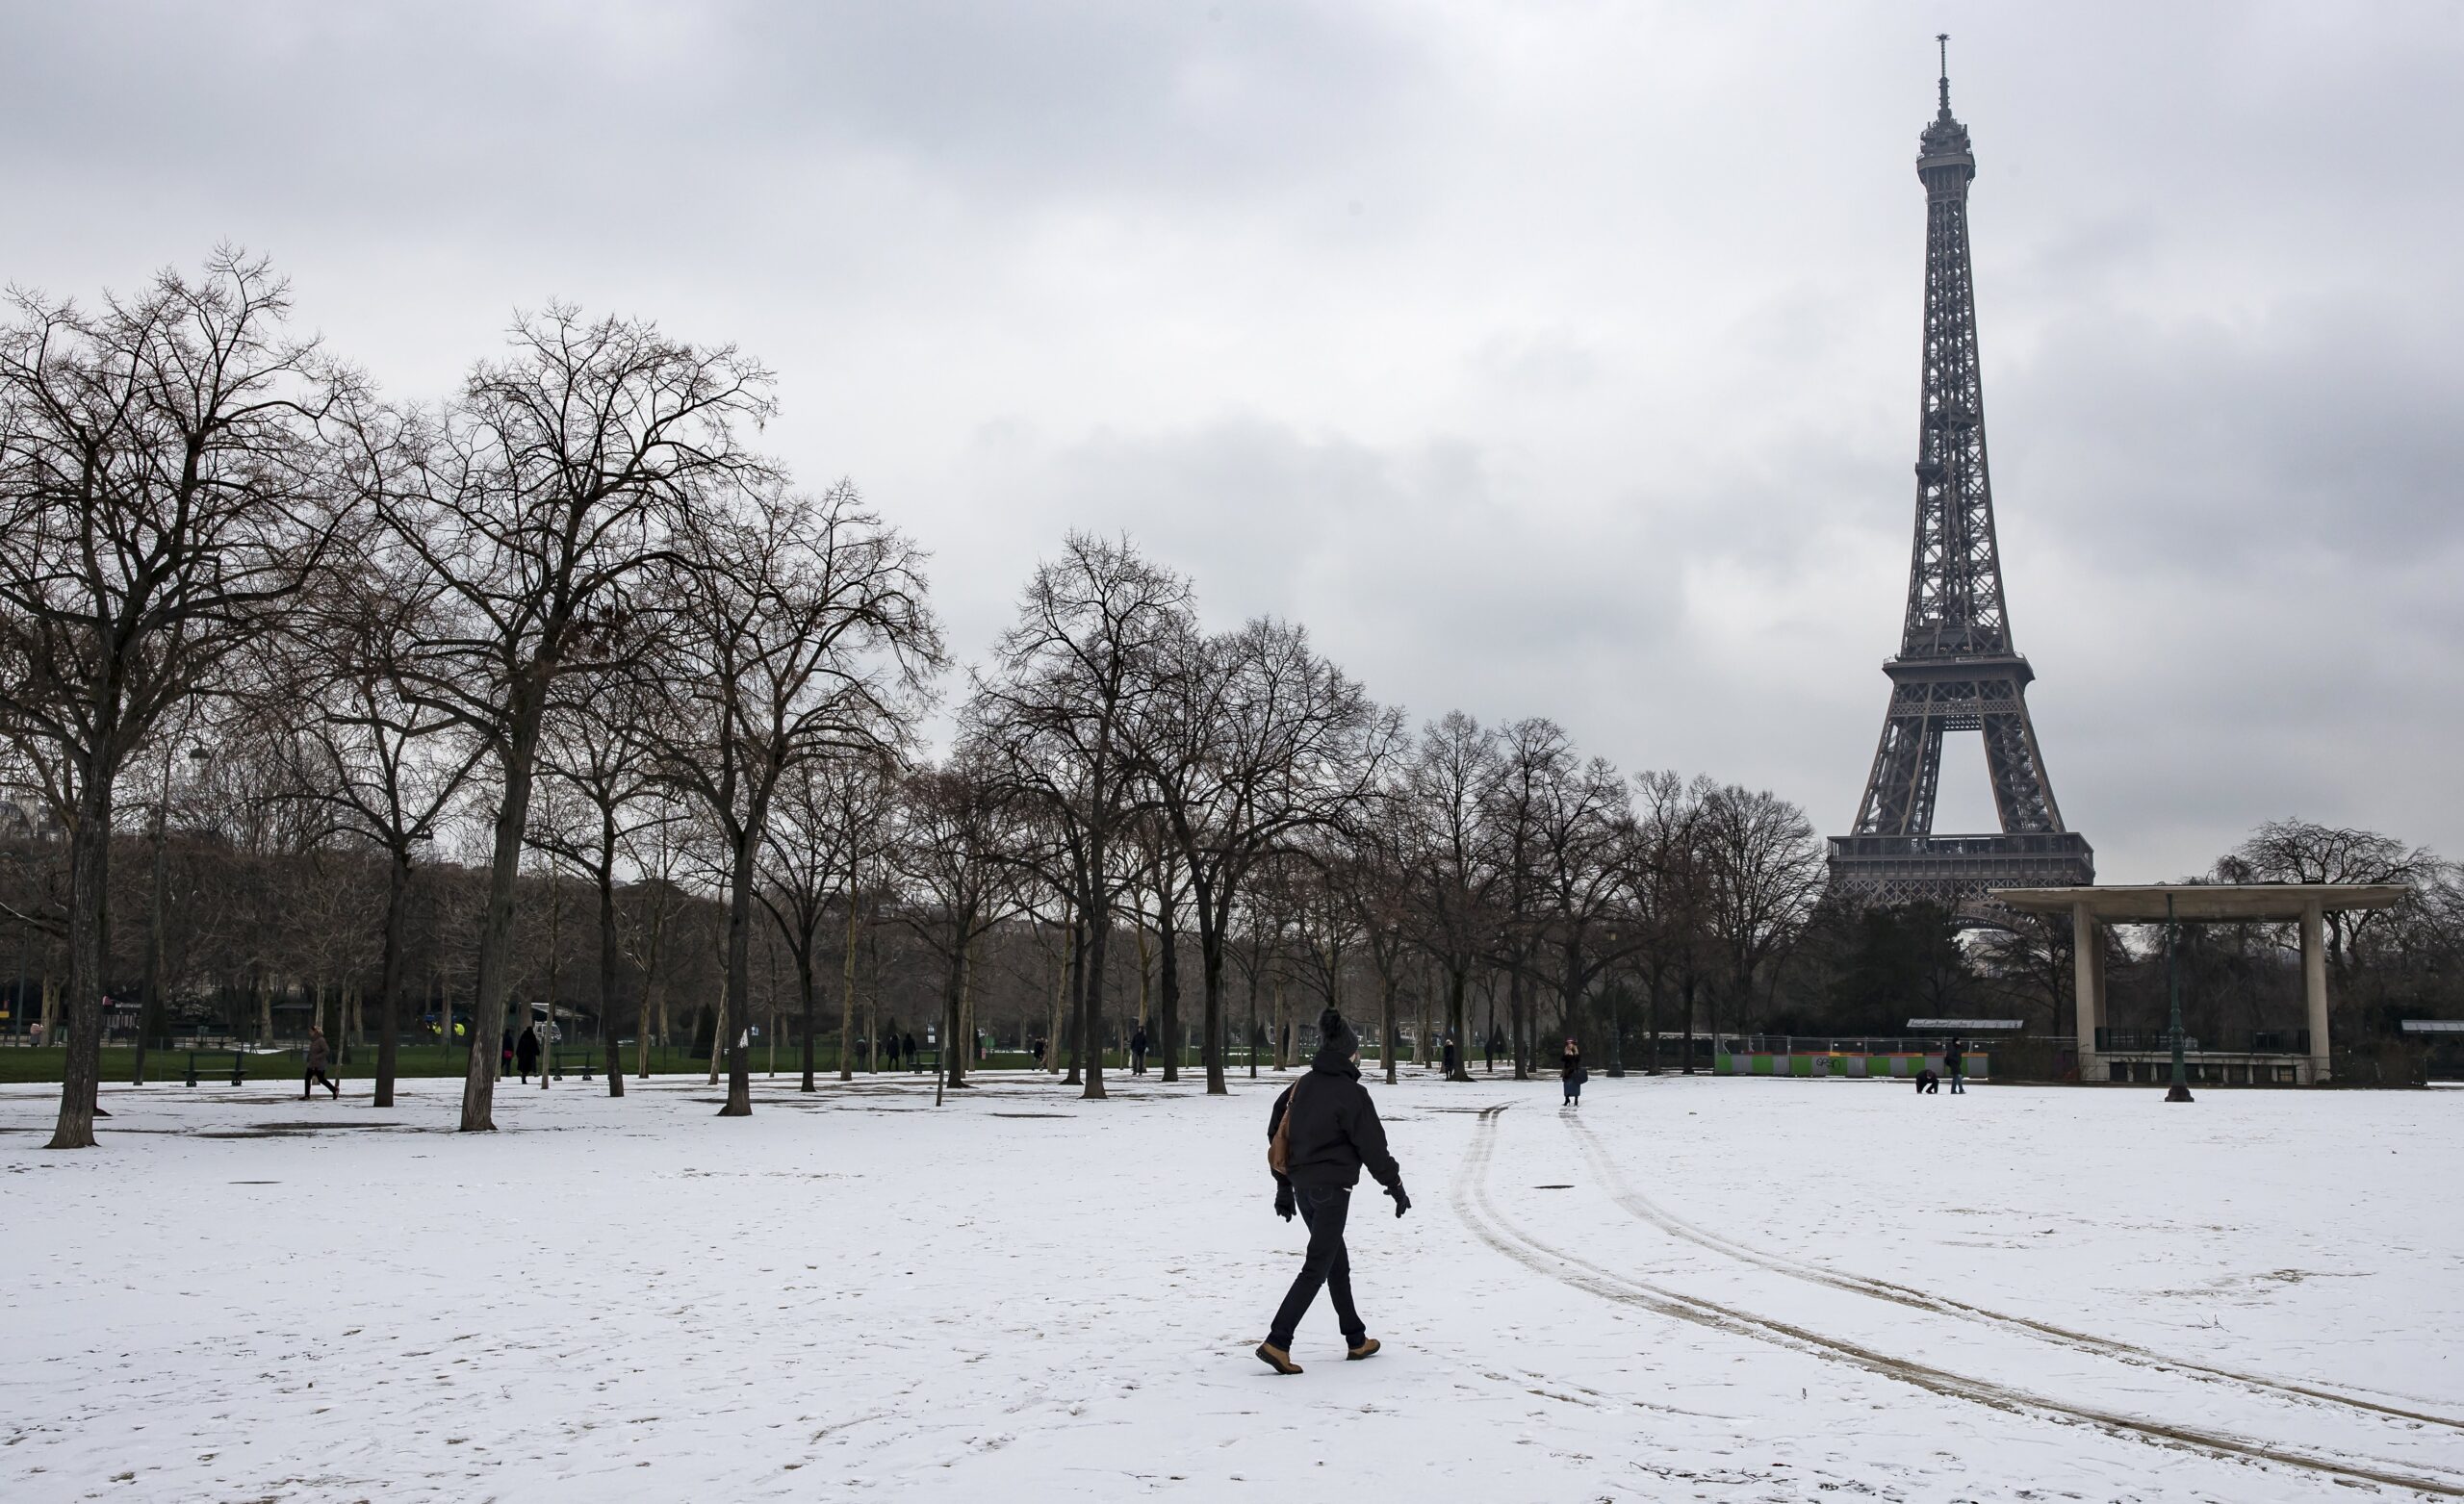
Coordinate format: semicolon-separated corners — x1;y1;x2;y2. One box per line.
1831;37;2097;913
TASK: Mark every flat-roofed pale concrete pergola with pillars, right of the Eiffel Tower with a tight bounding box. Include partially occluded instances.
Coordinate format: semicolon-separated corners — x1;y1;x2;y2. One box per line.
1993;883;2412;1085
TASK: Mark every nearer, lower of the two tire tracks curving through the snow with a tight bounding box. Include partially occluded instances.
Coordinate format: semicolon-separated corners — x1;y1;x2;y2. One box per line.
1451;1106;2464;1499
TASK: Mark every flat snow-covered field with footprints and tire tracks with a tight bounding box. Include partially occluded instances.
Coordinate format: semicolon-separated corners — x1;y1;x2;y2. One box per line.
0;1076;2464;1504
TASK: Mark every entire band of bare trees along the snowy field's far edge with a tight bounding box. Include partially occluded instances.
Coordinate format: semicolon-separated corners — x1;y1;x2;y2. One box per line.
0;251;2464;1147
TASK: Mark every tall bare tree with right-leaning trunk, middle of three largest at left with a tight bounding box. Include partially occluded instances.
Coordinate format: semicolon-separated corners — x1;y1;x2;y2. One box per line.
379;305;771;1133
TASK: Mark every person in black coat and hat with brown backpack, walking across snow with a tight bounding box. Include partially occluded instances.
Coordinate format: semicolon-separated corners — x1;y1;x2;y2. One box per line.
1257;1009;1412;1373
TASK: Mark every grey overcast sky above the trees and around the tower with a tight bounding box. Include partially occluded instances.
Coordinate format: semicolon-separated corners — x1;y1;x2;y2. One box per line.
0;0;2464;881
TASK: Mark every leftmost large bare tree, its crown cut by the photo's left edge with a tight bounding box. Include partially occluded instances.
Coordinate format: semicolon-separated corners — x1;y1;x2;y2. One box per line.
0;251;355;1150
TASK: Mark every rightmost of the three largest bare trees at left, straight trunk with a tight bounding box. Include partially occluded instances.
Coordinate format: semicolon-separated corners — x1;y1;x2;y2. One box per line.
658;482;941;1117
